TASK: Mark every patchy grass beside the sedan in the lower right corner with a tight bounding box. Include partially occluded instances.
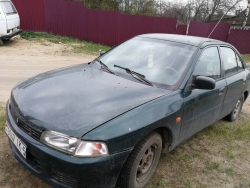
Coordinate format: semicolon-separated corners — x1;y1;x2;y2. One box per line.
147;115;250;188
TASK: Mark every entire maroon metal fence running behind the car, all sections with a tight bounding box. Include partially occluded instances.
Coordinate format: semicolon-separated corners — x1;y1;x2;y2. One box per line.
12;0;250;54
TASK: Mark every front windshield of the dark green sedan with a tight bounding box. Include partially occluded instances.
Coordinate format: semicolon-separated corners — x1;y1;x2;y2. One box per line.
99;37;196;86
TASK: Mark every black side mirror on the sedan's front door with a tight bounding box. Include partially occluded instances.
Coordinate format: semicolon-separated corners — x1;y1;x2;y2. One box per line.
192;76;215;90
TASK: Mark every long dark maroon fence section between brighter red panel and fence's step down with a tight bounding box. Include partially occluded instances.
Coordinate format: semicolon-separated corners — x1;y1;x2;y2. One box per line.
44;0;177;46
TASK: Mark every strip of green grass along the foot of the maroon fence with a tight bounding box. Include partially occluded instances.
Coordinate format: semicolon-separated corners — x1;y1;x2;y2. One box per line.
21;31;111;55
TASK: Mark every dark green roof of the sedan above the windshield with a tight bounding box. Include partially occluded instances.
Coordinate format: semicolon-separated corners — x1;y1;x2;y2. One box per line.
139;33;229;47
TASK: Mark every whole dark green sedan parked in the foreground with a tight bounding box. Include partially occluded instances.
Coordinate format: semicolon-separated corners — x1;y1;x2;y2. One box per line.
5;34;250;188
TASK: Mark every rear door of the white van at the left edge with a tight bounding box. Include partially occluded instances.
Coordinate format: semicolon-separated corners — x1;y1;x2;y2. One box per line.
0;1;20;30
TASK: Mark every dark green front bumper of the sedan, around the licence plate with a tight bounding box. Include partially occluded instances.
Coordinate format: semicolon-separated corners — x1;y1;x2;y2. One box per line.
6;103;129;188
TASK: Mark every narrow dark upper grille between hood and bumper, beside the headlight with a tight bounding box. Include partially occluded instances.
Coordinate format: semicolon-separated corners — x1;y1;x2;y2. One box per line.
9;99;43;140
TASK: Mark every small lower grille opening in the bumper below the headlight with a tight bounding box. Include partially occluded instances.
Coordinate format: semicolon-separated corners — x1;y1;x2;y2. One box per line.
51;168;79;187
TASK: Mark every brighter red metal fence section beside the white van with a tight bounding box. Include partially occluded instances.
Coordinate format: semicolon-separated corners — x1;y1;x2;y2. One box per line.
12;0;46;31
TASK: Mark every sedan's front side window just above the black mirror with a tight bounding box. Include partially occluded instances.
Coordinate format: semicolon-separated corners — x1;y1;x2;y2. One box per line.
193;47;221;79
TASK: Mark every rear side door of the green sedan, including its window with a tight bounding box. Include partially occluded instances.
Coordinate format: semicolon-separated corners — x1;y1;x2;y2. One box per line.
219;46;247;118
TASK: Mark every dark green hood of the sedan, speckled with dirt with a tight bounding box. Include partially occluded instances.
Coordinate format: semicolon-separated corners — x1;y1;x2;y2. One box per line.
11;64;170;137
